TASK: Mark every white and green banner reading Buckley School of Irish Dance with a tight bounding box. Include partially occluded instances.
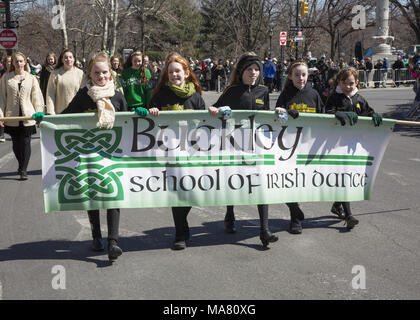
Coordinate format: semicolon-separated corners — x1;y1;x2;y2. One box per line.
41;111;395;212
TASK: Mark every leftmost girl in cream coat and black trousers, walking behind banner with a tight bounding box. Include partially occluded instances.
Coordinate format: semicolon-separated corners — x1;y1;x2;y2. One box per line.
0;51;44;180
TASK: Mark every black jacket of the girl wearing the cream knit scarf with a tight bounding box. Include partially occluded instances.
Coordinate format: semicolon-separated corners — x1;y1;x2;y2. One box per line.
62;87;128;113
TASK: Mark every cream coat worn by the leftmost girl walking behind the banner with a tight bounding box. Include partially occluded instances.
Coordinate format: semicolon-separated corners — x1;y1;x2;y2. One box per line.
0;71;44;127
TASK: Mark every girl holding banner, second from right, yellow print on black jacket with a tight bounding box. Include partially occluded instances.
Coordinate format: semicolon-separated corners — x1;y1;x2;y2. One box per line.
276;60;324;234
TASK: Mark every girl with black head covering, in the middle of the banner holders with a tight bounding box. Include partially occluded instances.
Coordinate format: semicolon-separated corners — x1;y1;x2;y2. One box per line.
209;52;278;247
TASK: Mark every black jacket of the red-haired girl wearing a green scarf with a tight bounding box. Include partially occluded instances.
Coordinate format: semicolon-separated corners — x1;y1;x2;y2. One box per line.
150;86;206;111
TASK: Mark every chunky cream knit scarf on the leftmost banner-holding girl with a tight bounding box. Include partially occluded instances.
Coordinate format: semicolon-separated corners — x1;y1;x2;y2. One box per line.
86;80;115;129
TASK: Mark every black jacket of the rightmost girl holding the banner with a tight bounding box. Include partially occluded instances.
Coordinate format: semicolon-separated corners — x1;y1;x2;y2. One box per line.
326;91;375;117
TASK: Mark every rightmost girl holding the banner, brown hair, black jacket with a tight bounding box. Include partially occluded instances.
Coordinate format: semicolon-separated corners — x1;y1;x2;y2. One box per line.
326;67;382;230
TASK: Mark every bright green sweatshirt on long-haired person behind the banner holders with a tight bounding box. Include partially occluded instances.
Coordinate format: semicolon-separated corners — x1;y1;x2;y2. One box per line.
121;68;152;108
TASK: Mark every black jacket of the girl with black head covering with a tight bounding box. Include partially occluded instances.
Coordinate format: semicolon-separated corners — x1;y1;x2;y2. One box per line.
214;84;270;110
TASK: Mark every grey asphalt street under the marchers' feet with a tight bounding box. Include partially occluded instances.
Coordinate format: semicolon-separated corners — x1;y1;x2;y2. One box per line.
0;88;420;302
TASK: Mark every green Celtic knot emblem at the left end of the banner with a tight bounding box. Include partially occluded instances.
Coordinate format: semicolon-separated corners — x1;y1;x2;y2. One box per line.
55;127;124;206
